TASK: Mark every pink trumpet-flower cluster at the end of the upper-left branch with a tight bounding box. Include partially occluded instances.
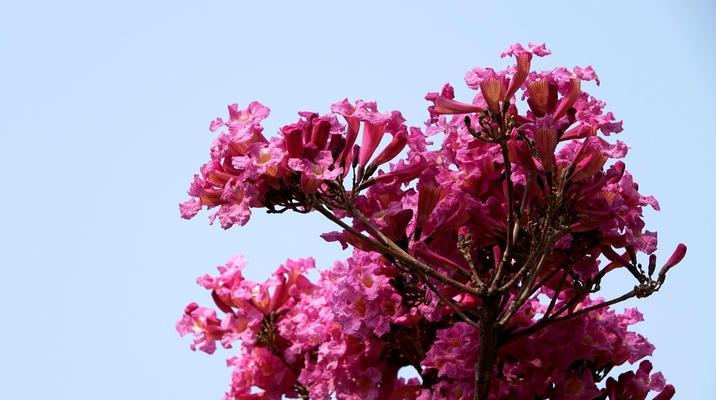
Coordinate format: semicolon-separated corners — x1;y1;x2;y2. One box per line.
179;99;408;229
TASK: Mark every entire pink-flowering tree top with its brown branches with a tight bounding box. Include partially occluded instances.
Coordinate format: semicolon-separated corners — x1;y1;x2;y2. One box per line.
177;43;686;400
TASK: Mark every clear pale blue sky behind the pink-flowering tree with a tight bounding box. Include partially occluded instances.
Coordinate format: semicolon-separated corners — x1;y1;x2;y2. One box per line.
0;0;716;400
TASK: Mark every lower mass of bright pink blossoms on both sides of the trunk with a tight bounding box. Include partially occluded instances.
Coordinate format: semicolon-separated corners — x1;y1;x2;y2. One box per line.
177;250;674;400
